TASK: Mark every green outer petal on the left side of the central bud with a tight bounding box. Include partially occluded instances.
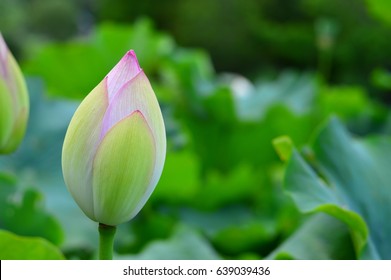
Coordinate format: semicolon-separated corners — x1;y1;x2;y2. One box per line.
62;80;107;220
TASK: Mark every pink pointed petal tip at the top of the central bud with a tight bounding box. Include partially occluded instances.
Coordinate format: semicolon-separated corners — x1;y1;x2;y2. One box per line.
107;50;141;103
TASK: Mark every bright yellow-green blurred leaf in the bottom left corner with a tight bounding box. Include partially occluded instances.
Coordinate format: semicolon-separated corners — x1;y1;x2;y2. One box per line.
0;230;64;260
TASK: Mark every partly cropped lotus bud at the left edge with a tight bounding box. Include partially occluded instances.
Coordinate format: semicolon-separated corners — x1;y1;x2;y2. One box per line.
0;33;29;154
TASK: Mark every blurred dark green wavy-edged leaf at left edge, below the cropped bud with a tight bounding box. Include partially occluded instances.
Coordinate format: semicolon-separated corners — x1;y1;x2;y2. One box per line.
0;173;64;245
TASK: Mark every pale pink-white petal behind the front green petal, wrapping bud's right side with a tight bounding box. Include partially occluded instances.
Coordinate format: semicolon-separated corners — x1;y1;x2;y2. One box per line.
101;71;166;208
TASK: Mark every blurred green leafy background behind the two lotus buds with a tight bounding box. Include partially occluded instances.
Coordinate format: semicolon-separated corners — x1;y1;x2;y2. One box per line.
0;0;391;259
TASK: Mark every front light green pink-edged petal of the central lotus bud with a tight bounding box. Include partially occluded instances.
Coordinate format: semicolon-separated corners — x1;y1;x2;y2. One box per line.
93;111;155;225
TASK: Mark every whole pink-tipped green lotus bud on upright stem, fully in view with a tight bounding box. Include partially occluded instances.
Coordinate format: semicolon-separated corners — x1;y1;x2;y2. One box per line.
62;51;166;226
